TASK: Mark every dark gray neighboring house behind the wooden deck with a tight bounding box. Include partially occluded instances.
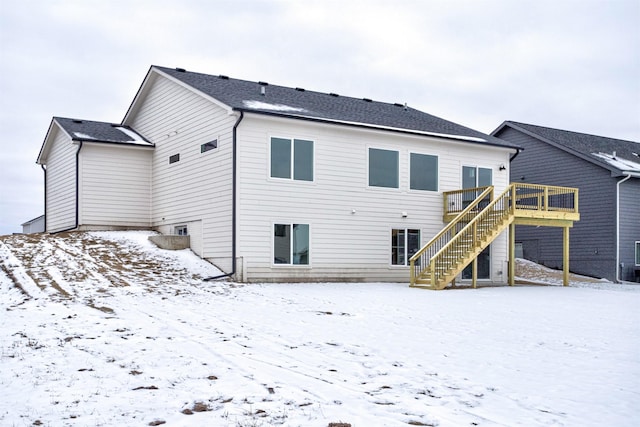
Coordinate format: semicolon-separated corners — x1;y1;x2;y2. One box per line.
492;121;640;281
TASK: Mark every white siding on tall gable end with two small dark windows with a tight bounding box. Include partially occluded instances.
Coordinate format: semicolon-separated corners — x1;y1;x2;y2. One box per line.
129;76;236;271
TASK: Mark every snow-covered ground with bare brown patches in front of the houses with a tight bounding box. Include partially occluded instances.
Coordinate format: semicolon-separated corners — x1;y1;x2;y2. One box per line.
0;232;640;427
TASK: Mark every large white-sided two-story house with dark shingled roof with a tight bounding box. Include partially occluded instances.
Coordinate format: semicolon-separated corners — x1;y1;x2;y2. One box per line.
38;66;584;287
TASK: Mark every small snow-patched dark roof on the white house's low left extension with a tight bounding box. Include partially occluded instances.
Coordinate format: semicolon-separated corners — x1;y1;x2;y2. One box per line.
53;117;153;147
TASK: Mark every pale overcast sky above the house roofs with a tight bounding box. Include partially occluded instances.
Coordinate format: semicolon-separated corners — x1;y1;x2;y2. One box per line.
0;0;640;235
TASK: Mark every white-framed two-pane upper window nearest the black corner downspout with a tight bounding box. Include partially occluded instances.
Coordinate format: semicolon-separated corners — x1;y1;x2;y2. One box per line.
271;138;313;181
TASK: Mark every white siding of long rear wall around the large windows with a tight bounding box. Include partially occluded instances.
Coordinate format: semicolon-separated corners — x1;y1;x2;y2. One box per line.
238;115;509;282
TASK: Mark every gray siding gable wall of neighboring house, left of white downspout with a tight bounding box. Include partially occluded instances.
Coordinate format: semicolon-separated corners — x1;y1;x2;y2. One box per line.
496;127;616;280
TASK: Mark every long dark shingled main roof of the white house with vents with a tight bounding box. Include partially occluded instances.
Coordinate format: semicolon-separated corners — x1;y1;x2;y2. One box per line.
152;66;517;148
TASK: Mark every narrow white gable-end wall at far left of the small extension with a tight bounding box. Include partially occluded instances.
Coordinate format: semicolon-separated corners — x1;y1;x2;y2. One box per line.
46;126;78;232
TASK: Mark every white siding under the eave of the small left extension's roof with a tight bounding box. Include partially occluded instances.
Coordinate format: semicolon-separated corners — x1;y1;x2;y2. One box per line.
80;143;152;227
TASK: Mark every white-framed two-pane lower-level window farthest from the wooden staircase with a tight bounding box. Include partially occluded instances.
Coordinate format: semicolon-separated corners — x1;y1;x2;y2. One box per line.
273;224;310;265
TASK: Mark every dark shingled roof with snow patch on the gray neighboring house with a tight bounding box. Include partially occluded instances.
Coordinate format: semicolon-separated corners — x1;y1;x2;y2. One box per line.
493;120;640;171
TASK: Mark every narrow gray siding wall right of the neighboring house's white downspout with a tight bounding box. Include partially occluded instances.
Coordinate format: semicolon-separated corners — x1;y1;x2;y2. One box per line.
618;178;640;281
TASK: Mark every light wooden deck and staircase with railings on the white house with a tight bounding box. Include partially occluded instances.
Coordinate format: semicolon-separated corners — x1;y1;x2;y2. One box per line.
410;184;579;290
